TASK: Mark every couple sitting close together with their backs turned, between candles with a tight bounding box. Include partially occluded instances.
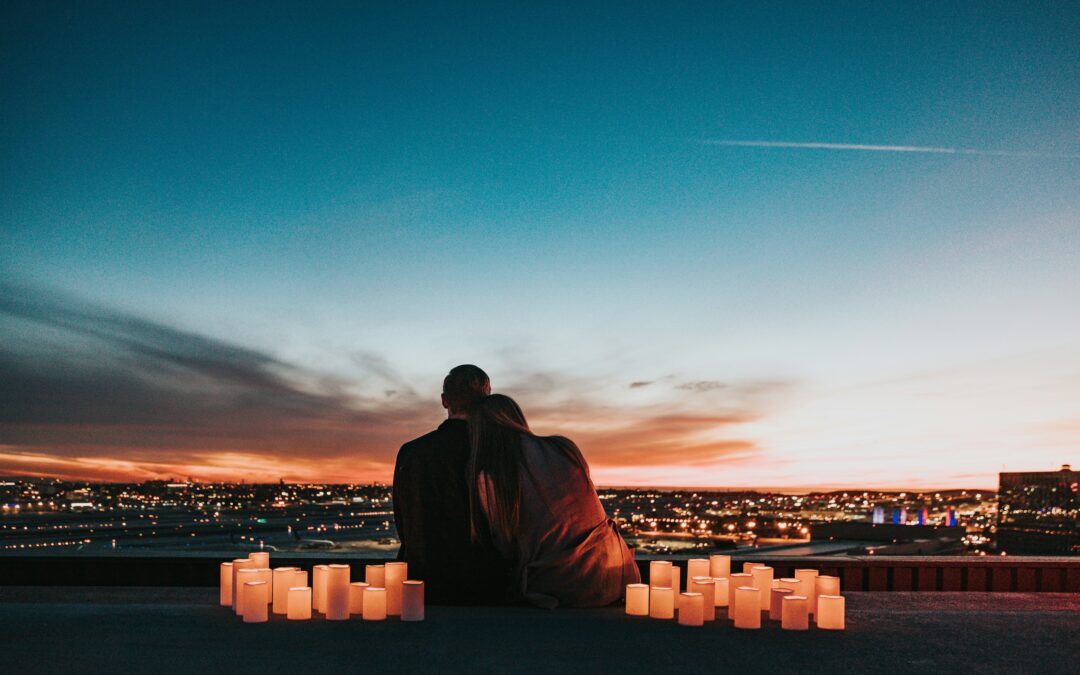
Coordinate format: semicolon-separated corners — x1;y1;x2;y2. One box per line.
394;365;639;607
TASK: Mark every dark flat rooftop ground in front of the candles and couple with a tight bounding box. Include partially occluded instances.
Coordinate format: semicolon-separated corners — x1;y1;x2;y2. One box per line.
0;586;1080;674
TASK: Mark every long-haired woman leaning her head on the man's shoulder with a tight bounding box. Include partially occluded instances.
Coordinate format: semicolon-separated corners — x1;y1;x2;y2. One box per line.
469;394;640;607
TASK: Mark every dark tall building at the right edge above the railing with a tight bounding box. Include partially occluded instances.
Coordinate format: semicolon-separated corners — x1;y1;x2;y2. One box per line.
998;464;1080;555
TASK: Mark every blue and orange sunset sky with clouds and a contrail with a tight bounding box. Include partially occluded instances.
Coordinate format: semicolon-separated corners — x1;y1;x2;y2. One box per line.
0;1;1080;488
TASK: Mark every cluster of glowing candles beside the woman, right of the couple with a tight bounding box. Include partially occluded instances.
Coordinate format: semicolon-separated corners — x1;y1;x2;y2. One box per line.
626;554;845;631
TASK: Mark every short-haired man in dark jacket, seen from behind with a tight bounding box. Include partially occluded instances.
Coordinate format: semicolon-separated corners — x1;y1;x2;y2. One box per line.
394;365;510;605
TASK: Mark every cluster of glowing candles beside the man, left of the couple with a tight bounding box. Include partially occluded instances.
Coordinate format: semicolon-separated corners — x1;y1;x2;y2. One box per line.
219;551;424;623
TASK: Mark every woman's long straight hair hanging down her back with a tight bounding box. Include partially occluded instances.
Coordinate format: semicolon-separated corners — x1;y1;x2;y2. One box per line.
469;394;532;541
